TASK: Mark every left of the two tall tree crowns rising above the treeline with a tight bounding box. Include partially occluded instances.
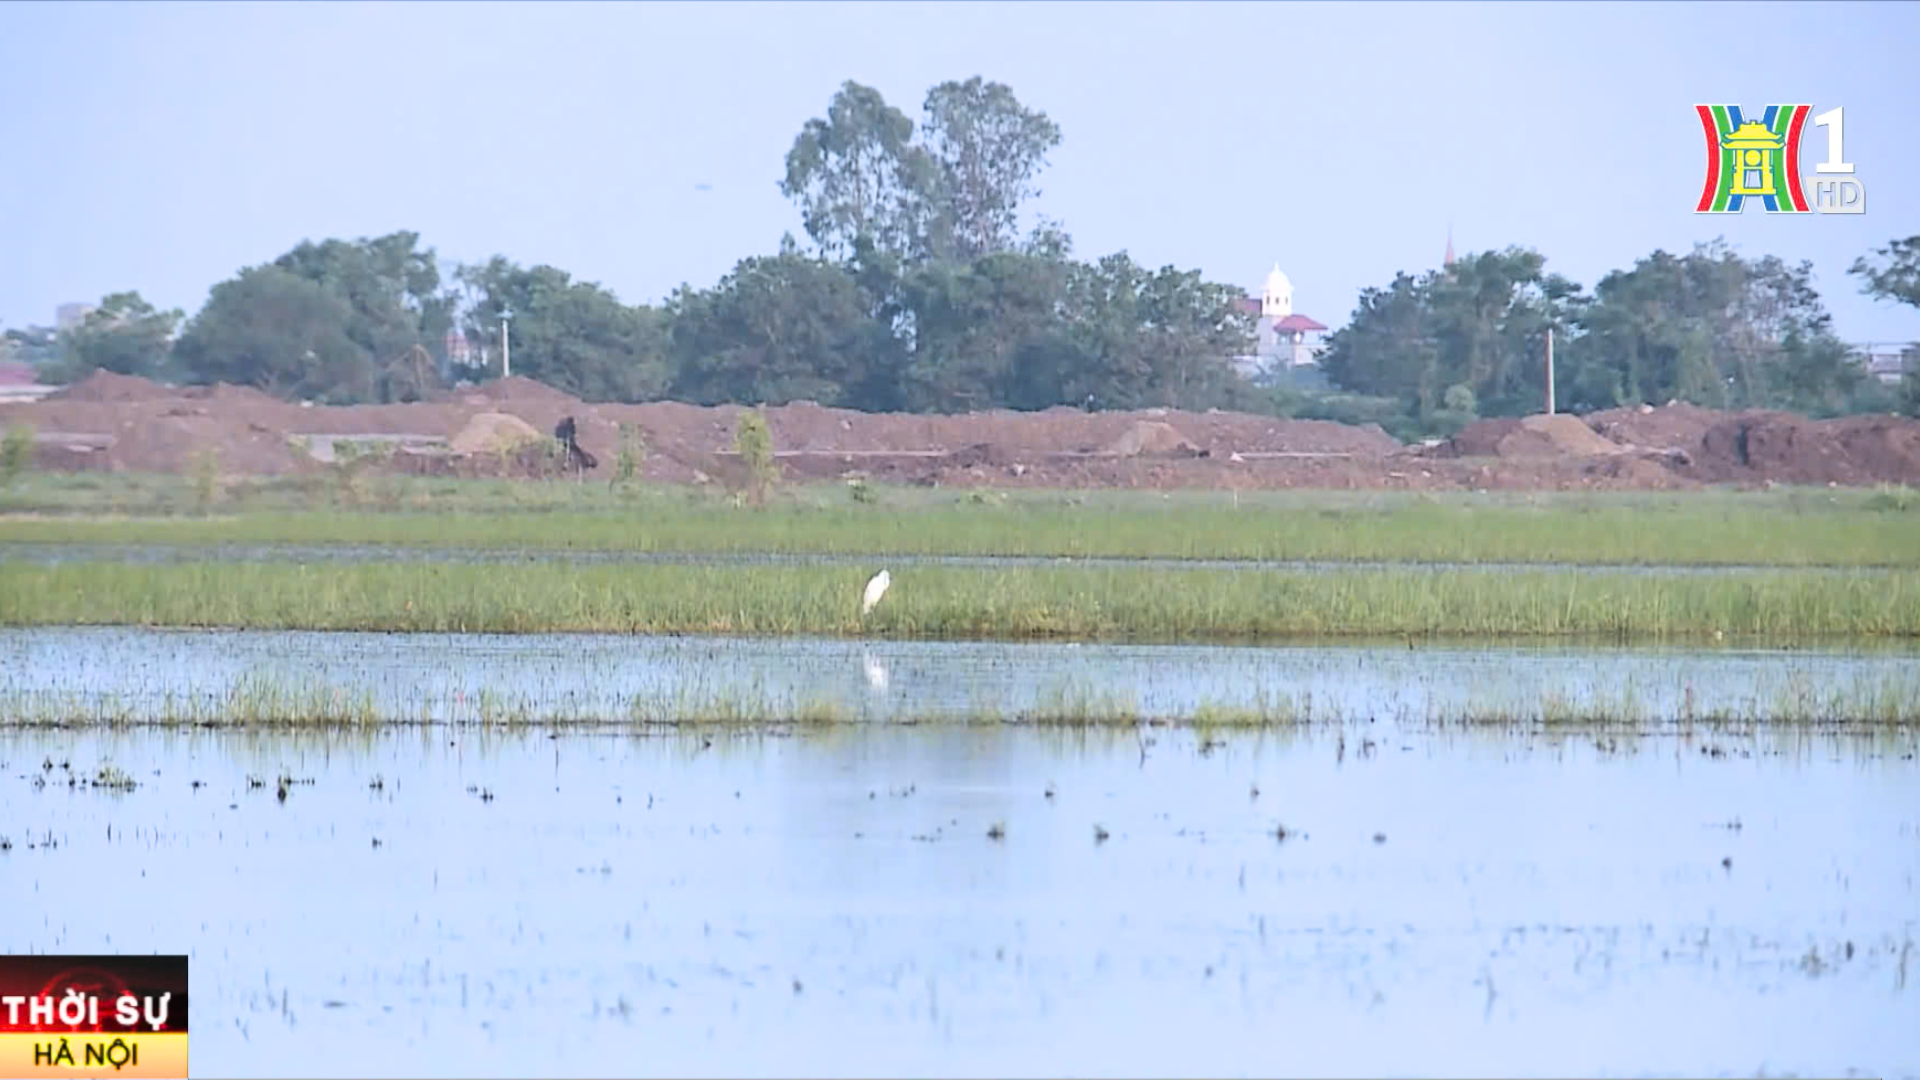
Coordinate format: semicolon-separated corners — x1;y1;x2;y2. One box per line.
780;81;935;258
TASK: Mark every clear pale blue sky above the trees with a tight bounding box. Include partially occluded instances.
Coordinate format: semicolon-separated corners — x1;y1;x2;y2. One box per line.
0;0;1920;340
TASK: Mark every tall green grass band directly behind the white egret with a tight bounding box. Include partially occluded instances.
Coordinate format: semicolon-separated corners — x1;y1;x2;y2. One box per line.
0;563;1920;640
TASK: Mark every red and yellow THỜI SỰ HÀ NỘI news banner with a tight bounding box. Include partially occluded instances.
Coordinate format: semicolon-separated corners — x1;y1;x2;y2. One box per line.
0;955;186;1076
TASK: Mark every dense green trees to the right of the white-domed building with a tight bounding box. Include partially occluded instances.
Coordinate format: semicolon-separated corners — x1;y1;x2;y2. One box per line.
1305;238;1920;429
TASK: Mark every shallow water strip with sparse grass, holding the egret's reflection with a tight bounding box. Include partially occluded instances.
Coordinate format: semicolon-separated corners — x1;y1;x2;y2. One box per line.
0;628;1920;724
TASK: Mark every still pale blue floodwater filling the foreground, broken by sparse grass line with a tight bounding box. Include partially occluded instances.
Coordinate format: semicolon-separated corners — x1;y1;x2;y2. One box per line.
0;630;1920;1076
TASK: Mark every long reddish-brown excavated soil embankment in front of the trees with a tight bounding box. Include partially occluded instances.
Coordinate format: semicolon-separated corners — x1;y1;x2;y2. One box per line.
0;373;1920;488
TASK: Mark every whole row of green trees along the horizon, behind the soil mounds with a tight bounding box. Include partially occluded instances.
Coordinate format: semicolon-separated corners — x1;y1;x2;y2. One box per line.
6;77;1920;434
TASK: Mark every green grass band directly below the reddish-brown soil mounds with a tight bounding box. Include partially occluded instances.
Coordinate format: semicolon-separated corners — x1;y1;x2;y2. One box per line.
0;479;1920;567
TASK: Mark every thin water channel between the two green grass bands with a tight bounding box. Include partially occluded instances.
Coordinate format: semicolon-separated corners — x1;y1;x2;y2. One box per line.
0;540;1903;577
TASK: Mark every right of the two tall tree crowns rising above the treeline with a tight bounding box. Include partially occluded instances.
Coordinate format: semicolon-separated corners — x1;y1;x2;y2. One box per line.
922;75;1060;259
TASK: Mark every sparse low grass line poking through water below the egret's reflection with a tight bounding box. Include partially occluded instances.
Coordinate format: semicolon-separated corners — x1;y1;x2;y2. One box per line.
0;671;1920;722
